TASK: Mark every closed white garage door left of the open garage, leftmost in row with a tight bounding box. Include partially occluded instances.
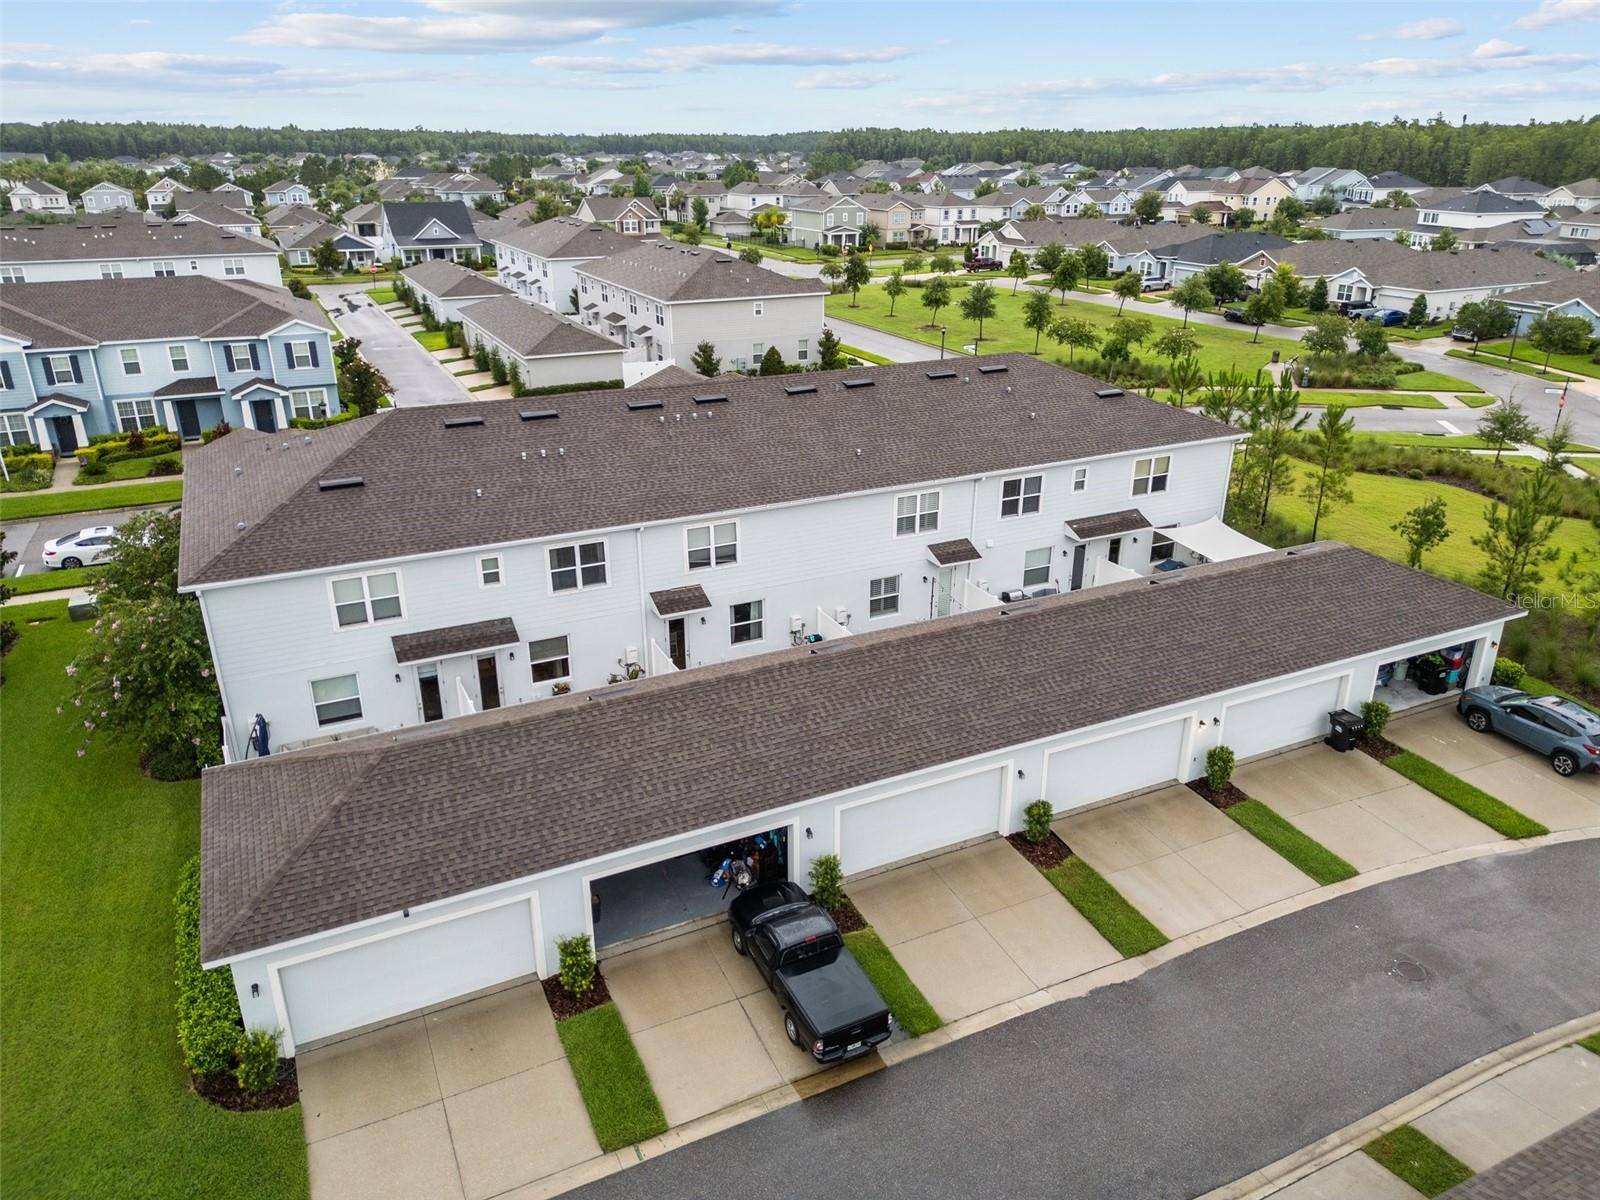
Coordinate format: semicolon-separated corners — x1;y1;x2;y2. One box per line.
278;899;534;1046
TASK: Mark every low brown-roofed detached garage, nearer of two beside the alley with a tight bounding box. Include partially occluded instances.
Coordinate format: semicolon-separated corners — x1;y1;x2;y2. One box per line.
457;299;624;392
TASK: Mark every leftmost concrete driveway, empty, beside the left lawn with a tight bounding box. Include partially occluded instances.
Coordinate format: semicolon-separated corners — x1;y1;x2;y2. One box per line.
298;982;600;1200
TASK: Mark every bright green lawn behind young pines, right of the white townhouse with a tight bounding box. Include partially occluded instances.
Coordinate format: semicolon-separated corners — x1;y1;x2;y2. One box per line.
1272;467;1600;579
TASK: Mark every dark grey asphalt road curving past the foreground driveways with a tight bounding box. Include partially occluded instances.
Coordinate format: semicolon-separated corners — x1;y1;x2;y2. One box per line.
574;840;1600;1200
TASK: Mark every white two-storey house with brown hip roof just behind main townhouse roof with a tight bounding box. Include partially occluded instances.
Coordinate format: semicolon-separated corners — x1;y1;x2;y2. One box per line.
573;241;825;371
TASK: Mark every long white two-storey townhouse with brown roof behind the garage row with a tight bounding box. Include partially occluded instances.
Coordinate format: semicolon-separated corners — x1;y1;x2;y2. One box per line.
179;352;1254;761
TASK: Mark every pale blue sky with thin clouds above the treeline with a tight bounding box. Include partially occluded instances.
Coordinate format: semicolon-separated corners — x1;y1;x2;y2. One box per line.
0;0;1600;133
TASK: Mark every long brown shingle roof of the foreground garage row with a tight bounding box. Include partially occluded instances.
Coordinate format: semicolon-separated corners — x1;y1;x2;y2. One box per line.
202;540;1520;962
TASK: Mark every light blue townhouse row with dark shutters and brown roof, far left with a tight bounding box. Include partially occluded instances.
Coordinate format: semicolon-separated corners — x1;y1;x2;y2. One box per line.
0;275;339;454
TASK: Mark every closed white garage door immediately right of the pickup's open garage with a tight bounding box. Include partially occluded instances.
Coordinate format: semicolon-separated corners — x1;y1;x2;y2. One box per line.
838;766;1005;875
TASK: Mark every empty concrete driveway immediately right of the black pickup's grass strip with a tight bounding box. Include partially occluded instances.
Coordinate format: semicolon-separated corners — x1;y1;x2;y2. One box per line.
850;840;1122;1021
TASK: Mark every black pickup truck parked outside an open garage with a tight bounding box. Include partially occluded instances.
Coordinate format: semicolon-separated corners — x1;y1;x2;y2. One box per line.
728;880;894;1062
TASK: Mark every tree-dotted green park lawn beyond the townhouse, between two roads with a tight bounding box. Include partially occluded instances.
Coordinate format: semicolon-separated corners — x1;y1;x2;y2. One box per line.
824;285;1298;373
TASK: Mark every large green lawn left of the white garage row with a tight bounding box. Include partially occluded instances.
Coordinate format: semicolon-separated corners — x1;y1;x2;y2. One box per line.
0;600;307;1200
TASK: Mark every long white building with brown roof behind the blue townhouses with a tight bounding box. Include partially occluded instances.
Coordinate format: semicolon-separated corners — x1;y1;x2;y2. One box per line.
0;213;283;286
